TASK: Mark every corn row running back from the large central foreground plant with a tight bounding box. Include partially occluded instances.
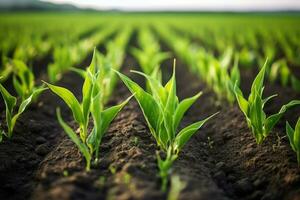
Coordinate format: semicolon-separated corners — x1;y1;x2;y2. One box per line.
116;27;218;191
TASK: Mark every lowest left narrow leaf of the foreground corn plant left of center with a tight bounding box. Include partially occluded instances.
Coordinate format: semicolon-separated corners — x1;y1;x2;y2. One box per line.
56;108;91;170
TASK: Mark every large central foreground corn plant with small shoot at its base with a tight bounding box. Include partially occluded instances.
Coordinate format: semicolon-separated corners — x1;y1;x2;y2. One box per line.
116;61;215;191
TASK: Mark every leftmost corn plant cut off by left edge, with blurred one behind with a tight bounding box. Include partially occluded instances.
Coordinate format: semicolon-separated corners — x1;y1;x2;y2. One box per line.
0;60;45;142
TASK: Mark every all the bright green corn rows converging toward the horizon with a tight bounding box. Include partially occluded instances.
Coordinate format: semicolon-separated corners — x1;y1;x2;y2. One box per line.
0;15;300;195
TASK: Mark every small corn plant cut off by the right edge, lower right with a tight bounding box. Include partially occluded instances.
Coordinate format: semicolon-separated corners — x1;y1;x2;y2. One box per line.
286;117;300;167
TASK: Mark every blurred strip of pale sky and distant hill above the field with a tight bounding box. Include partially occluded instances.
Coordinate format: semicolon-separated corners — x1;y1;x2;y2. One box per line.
0;0;300;11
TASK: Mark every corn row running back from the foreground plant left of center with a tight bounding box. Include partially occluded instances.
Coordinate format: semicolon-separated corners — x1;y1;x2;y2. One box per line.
42;27;132;171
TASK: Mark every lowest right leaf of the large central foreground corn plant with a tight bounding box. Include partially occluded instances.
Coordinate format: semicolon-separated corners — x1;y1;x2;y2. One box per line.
174;113;218;152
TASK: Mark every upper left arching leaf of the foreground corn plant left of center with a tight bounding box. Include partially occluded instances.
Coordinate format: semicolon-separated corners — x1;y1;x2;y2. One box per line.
45;82;84;123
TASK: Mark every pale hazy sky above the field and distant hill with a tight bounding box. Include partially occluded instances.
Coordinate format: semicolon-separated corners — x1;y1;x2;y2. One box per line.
41;0;300;10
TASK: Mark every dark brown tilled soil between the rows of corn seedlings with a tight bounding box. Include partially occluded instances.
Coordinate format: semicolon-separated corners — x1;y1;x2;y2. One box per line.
0;32;300;200
